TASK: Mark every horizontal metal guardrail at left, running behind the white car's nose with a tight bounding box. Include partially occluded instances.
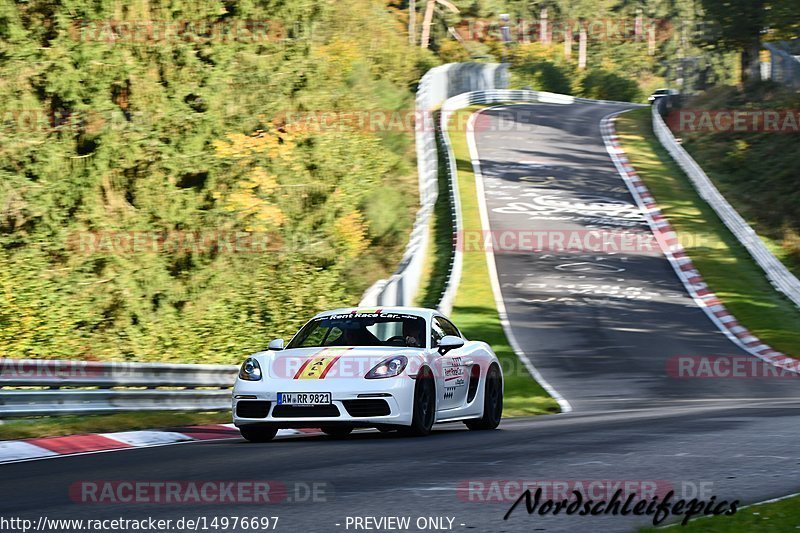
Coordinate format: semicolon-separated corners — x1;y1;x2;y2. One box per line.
0;359;238;419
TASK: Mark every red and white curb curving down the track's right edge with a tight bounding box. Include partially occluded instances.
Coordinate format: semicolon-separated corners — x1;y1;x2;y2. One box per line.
600;111;800;372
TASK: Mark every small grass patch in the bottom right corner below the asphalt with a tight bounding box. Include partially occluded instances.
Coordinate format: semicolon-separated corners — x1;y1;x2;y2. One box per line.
641;496;800;533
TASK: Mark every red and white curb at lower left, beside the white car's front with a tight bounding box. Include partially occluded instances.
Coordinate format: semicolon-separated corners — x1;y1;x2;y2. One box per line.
0;424;322;464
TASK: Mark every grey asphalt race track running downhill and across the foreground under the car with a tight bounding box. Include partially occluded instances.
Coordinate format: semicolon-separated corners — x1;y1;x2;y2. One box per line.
0;104;800;532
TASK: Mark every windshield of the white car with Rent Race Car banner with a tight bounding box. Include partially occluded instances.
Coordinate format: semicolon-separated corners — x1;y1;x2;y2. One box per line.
287;313;426;348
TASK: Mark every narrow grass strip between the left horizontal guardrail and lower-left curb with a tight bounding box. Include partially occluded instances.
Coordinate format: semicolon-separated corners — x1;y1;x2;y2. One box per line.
0;411;231;440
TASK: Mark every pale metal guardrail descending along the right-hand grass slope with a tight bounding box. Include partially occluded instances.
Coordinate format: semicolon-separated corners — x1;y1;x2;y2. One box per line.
652;102;800;307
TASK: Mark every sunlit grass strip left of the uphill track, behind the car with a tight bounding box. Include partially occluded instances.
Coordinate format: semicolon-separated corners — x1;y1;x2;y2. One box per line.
450;106;560;416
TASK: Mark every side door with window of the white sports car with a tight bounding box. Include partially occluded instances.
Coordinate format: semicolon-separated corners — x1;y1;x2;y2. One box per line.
431;316;467;409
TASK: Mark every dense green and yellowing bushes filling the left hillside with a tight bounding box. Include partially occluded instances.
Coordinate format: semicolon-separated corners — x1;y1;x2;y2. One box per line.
0;0;434;362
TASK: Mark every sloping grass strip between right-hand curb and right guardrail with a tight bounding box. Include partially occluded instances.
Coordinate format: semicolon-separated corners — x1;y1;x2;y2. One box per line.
616;109;800;357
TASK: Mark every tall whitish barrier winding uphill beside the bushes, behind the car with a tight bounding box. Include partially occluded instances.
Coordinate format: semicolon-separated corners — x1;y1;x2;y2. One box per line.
360;63;508;306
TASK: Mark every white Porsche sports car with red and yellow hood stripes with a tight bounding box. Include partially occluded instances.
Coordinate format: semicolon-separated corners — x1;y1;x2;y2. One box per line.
233;307;503;442
